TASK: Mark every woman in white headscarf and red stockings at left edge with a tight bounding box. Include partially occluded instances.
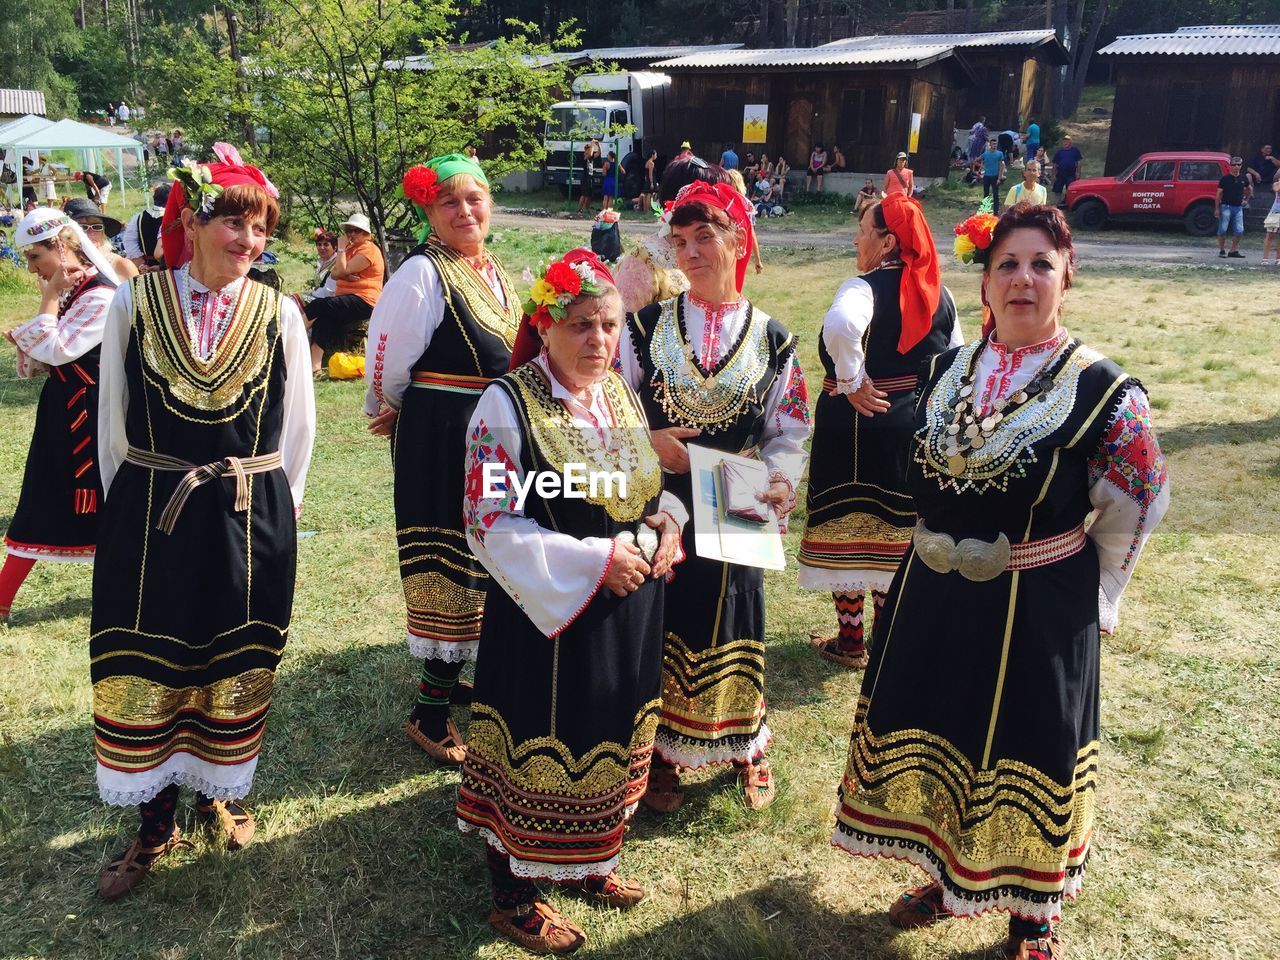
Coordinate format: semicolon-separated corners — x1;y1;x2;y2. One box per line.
0;207;118;622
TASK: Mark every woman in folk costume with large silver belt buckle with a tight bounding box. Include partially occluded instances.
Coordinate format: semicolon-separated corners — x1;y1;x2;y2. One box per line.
832;204;1169;960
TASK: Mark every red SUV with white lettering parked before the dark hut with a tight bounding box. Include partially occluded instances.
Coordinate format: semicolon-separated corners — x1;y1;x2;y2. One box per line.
1066;150;1231;237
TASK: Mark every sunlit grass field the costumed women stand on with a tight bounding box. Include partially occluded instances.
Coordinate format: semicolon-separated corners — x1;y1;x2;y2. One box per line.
0;230;1280;960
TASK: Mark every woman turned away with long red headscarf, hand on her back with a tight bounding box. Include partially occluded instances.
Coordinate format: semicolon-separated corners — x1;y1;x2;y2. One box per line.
800;193;964;668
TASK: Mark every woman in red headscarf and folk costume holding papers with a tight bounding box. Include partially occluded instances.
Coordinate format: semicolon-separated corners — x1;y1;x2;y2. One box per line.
618;182;809;812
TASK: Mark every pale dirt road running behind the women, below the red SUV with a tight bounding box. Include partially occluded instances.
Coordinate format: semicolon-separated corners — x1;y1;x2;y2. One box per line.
493;207;1280;275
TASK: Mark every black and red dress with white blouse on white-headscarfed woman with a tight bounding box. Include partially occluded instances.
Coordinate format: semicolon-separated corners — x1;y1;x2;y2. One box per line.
4;271;115;562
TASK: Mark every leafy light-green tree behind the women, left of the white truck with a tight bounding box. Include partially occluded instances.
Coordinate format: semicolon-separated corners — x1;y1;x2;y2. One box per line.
150;0;576;239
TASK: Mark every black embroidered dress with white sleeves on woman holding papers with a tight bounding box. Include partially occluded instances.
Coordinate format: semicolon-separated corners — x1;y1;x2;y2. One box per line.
620;294;809;768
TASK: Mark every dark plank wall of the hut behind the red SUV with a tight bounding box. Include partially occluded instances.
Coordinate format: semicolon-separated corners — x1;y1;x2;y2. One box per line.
1106;56;1280;175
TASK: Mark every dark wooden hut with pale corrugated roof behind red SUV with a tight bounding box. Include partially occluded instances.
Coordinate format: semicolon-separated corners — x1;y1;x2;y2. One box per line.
1098;24;1280;174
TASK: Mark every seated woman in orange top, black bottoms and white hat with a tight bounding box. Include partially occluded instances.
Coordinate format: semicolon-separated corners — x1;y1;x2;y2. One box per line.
306;214;387;374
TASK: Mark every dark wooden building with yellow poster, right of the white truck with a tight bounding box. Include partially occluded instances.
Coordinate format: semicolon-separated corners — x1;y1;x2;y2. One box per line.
654;37;974;177
